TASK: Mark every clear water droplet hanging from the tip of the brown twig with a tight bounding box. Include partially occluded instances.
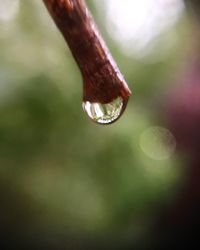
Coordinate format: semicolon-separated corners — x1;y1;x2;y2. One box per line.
83;97;128;125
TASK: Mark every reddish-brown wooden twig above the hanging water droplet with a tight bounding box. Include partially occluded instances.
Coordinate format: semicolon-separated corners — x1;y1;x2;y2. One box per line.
43;0;131;103
